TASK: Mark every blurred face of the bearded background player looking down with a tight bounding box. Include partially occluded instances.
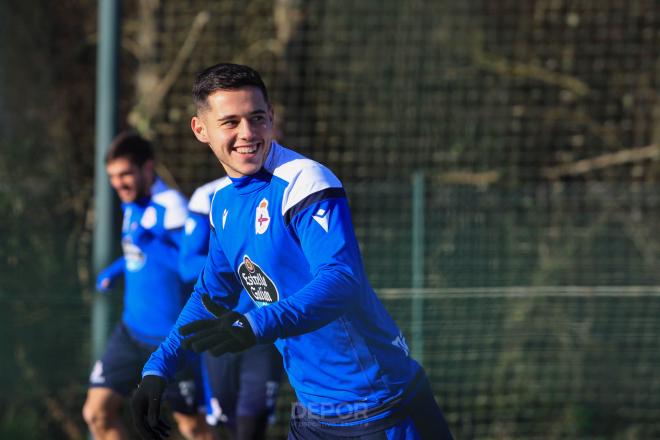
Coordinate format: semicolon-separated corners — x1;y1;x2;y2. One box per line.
105;157;153;203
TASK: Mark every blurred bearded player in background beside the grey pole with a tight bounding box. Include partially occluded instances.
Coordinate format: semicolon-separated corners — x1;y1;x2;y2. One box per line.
83;133;215;439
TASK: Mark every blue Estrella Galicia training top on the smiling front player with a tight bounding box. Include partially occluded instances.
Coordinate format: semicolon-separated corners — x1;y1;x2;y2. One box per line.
143;142;420;416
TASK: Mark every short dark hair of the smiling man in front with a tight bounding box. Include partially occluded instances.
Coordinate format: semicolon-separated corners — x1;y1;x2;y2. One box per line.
192;63;268;110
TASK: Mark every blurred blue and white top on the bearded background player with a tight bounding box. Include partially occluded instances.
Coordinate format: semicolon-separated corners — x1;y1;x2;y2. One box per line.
102;178;189;345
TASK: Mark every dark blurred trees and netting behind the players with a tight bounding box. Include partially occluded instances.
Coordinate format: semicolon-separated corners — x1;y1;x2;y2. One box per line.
0;0;660;439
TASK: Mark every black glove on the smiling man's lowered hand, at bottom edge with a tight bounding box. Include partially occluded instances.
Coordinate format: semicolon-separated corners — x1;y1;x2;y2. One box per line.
131;375;170;440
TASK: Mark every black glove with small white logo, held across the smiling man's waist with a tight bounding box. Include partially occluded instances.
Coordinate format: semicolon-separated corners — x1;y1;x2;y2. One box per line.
179;294;257;356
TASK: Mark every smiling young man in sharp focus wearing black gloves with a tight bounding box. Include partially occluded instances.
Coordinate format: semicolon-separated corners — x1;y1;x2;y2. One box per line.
132;64;451;440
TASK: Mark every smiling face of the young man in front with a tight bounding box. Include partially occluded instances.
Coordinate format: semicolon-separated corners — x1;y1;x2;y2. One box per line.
190;86;273;177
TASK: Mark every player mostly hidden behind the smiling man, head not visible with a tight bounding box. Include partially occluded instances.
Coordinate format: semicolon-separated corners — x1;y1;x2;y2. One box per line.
179;179;282;440
